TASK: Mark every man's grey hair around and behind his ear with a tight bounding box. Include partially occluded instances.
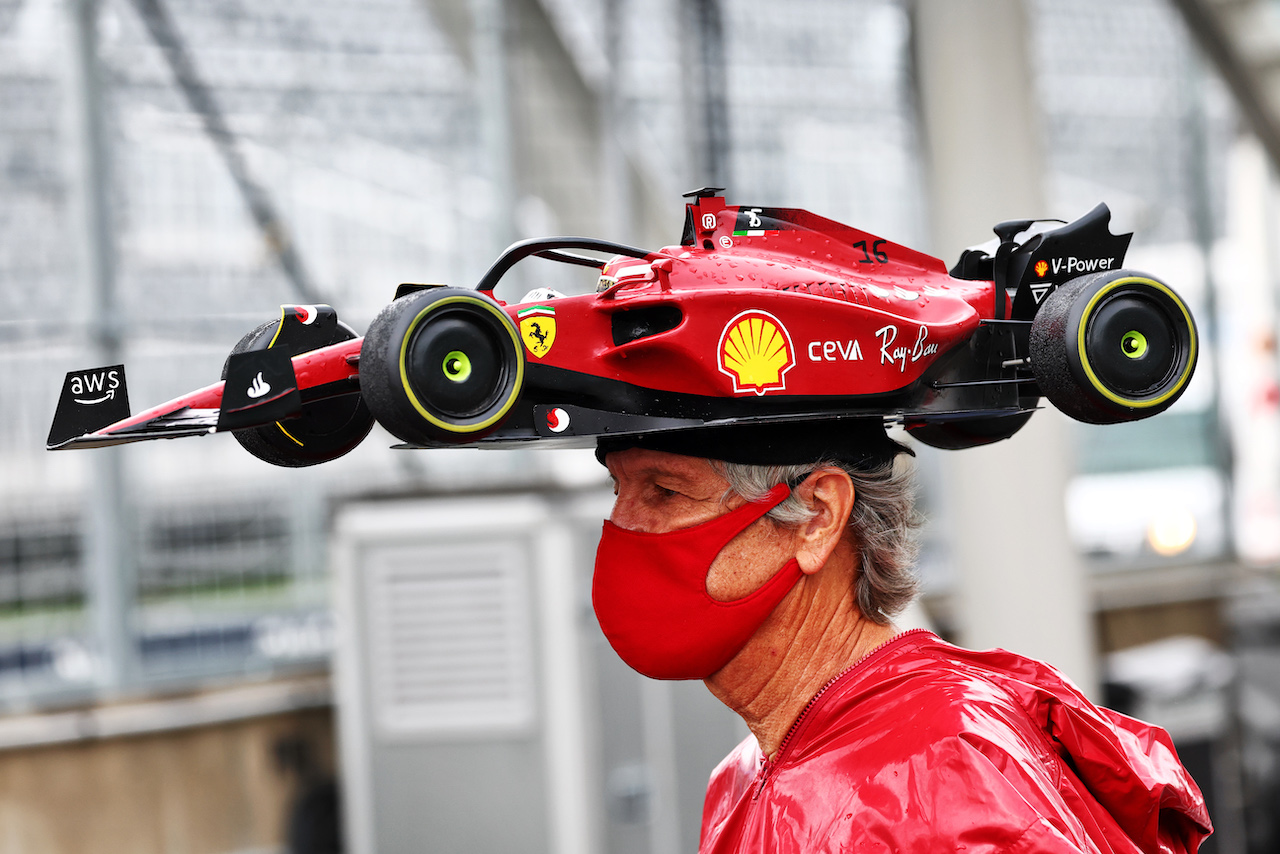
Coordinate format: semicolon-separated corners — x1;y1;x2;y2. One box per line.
710;460;920;625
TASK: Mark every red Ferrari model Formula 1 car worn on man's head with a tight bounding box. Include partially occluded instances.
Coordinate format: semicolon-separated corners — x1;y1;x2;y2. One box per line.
49;189;1198;466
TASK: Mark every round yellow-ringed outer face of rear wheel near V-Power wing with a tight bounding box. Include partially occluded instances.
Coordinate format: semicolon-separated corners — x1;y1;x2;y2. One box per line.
1078;278;1196;407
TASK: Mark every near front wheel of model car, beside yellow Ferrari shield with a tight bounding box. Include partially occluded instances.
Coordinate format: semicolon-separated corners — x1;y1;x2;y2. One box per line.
360;288;525;444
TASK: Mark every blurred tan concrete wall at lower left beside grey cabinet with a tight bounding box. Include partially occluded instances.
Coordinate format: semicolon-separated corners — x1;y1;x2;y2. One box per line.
0;708;333;854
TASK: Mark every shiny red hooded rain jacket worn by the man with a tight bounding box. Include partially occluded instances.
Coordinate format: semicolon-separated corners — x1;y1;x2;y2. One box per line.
700;630;1212;854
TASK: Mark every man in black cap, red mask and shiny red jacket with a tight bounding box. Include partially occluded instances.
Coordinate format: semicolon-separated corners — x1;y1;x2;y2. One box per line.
593;420;1211;853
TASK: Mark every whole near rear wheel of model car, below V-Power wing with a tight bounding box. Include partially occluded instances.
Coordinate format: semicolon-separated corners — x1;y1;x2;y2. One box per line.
1030;270;1199;424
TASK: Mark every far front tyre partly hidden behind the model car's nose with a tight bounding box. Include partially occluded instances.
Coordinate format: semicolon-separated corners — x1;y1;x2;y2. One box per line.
223;320;374;469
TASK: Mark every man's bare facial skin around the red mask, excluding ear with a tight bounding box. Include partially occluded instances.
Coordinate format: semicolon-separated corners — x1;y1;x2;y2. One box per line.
604;448;796;602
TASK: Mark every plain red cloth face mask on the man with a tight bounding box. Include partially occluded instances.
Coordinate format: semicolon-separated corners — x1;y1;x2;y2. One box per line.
591;484;801;679
